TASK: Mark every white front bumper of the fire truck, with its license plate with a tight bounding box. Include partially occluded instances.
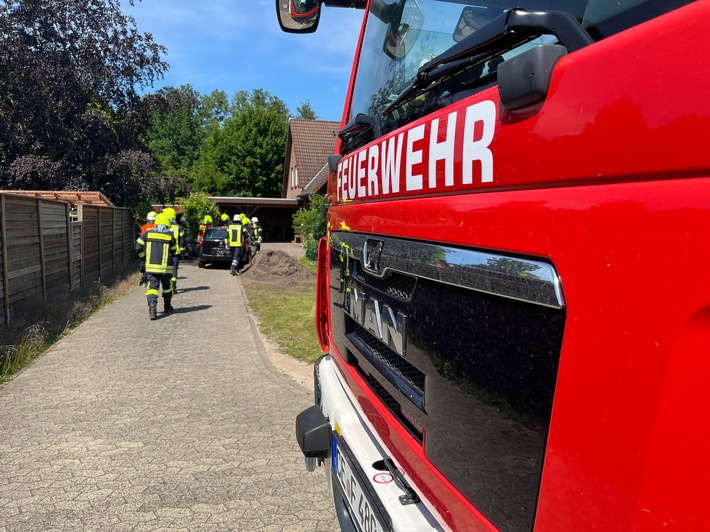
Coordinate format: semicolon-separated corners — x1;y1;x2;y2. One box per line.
296;356;445;532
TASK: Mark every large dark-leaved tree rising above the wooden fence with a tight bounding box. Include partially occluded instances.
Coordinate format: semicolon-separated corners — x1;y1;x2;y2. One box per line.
0;0;167;204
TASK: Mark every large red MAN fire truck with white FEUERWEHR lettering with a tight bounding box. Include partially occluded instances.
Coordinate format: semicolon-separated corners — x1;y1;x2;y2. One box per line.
276;0;710;532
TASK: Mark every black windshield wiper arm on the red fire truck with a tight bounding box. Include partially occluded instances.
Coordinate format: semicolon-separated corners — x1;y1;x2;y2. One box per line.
384;8;594;114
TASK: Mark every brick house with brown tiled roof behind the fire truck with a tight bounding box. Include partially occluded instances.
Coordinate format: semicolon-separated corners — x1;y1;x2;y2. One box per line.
281;119;340;198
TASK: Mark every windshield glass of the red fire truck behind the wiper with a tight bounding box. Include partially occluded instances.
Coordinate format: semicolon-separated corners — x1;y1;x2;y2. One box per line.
342;0;690;153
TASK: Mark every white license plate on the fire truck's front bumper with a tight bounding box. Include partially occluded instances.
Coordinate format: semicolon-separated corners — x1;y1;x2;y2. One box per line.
331;434;391;532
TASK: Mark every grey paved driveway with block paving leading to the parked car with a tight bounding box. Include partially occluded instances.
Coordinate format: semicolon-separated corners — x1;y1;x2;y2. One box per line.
0;264;338;531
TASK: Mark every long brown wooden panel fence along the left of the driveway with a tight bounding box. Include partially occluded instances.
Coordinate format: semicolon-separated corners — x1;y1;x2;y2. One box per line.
0;194;135;323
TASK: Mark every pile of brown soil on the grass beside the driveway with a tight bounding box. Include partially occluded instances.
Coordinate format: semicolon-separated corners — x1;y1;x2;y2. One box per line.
240;249;316;290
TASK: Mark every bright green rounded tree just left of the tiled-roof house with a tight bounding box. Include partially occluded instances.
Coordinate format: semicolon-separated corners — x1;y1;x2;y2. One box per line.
202;89;289;197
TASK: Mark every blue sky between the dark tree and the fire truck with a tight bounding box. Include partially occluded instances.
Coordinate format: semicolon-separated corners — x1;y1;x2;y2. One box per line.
122;0;364;121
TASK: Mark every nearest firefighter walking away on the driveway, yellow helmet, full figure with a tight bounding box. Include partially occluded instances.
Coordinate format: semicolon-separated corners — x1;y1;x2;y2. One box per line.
136;213;177;320
